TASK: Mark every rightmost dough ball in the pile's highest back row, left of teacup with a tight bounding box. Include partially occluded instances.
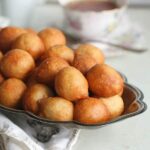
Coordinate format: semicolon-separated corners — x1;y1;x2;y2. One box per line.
38;28;66;50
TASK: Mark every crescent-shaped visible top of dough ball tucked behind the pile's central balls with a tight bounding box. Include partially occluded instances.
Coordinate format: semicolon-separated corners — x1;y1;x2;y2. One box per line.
41;45;74;64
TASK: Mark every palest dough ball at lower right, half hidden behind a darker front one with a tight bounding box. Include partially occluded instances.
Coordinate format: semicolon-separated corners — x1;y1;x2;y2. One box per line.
100;95;124;119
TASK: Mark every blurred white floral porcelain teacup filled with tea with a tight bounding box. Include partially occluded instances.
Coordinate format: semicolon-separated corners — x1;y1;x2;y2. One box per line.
59;0;127;40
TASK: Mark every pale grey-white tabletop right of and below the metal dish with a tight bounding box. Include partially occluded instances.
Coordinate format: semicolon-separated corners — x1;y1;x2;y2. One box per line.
73;8;150;150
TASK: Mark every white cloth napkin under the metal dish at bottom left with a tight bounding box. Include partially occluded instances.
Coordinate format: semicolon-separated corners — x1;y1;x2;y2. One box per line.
0;114;80;150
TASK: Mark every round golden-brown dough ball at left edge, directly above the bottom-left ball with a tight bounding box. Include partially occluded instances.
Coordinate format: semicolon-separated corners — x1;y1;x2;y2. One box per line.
0;49;35;79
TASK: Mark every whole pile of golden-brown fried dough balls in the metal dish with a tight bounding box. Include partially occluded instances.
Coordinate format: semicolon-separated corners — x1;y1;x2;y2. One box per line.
0;26;124;124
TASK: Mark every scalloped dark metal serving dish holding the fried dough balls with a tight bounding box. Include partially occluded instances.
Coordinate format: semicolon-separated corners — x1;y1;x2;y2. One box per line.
0;76;147;142
